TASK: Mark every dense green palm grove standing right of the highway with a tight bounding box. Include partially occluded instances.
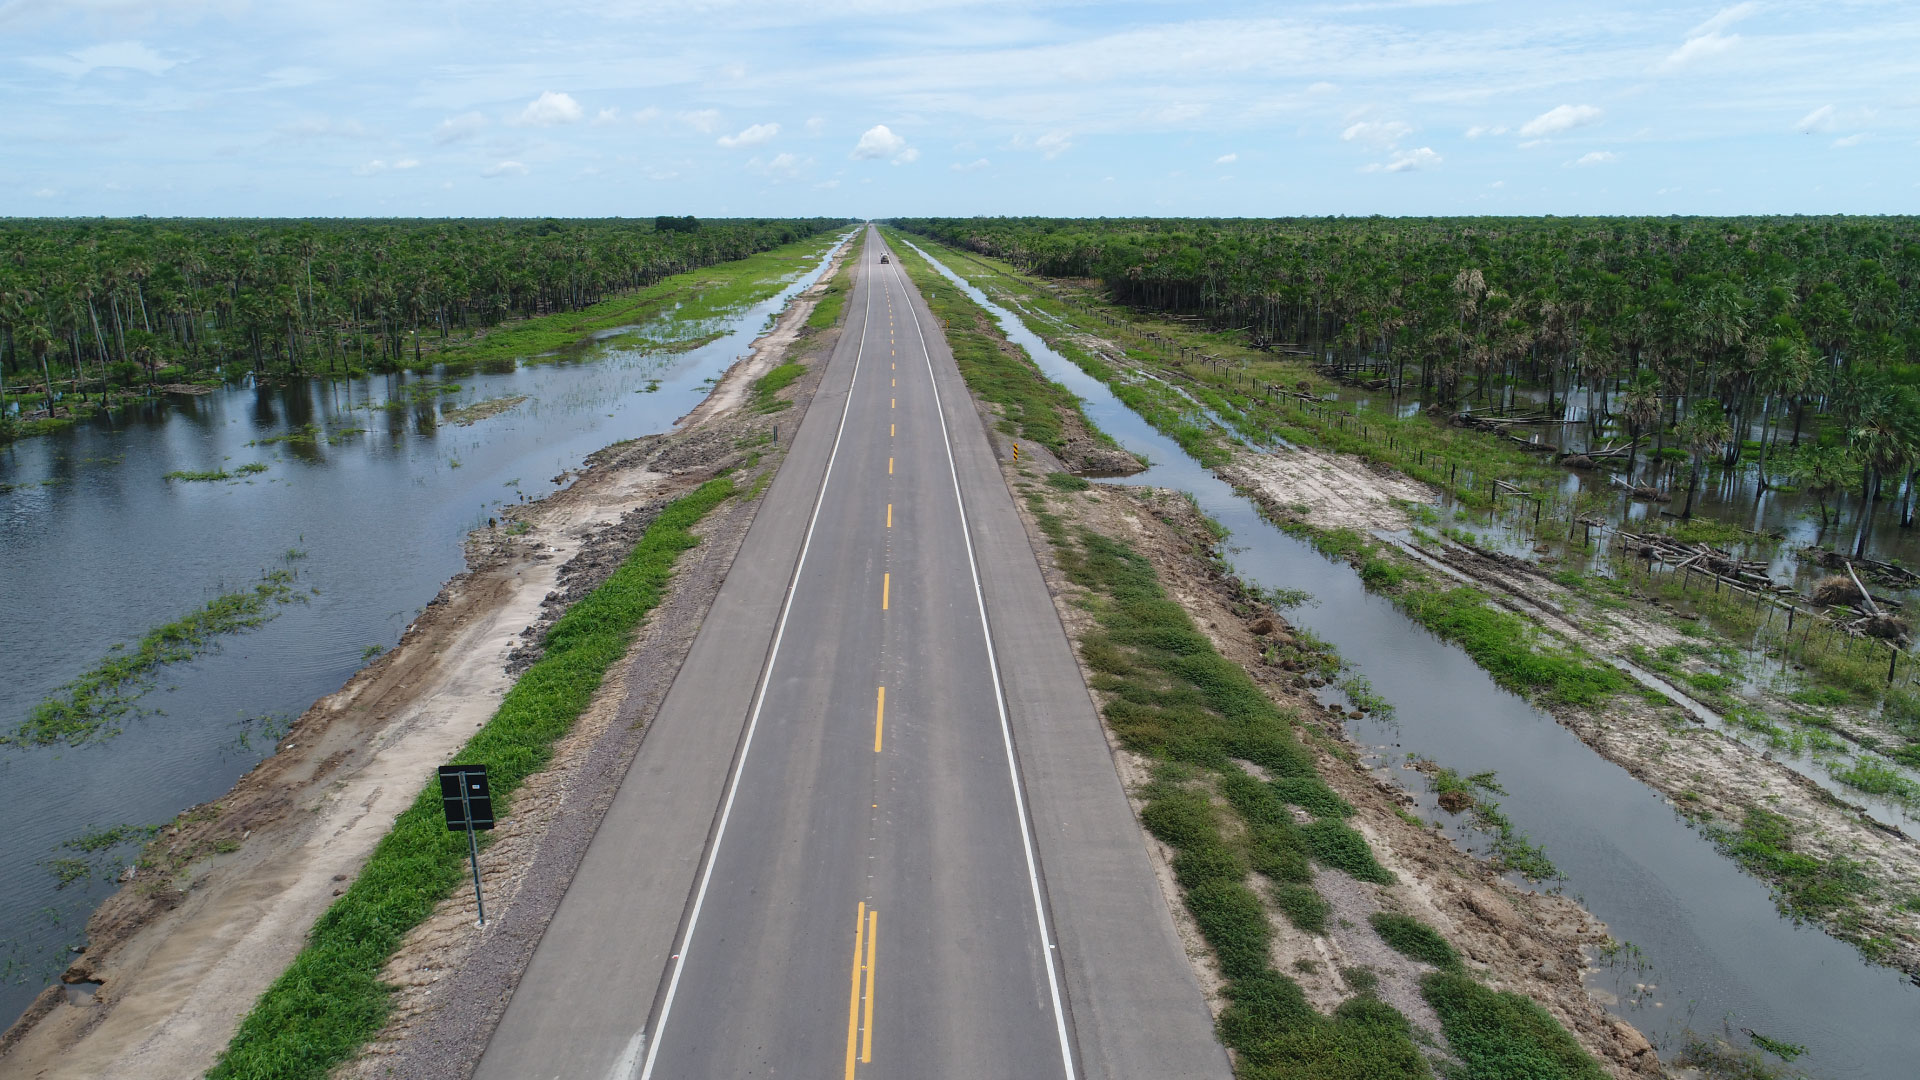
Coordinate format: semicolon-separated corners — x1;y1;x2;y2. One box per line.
895;217;1920;540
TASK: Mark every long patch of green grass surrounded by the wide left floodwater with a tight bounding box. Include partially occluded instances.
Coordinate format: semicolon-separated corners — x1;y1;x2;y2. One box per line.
0;571;296;746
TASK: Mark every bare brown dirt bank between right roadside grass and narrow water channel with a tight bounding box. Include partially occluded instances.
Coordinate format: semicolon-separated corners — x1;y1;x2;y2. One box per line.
1006;438;1661;1078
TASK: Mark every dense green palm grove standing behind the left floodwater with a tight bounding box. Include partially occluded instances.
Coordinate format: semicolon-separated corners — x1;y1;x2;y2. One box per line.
0;217;841;438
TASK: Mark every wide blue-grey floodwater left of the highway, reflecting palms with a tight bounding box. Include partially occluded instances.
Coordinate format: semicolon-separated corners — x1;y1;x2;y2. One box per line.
0;236;845;1028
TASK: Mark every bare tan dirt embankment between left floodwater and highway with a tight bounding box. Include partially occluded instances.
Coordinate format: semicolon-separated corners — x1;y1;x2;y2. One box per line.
0;242;856;1078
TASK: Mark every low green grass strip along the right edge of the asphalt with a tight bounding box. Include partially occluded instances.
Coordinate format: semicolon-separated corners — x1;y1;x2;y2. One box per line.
895;233;1603;1080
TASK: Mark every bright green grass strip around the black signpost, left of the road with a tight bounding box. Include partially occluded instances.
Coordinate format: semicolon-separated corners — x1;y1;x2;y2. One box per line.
209;477;733;1080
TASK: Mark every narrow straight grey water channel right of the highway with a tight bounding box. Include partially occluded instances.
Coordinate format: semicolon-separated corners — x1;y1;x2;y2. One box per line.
916;239;1920;1078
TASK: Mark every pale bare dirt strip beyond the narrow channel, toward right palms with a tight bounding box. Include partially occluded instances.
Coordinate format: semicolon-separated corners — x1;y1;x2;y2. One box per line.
1219;443;1920;974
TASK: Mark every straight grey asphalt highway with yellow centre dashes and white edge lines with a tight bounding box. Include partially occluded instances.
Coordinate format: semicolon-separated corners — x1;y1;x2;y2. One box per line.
478;233;1227;1080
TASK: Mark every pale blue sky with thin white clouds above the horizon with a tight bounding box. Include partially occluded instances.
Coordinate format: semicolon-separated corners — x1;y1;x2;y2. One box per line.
0;0;1920;217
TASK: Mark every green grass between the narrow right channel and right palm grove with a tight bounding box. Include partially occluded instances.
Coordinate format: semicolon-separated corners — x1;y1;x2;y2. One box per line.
910;231;1920;957
